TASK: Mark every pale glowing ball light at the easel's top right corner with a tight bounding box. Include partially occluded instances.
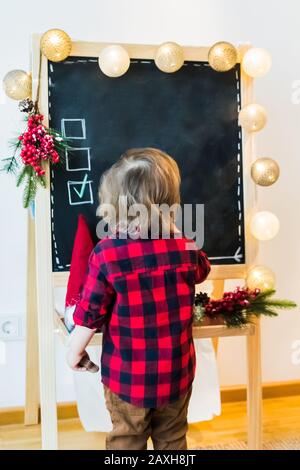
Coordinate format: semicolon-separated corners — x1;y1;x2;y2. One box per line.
242;47;272;78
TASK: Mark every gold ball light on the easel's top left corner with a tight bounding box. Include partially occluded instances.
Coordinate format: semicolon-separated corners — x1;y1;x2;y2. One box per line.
41;29;72;62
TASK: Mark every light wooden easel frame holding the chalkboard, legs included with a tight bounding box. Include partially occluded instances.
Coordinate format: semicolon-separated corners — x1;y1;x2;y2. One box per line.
25;35;261;449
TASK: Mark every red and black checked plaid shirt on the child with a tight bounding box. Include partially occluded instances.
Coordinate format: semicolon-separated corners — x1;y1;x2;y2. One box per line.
74;238;210;408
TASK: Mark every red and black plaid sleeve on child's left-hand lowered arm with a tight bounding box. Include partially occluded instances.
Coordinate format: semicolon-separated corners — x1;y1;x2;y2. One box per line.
74;251;115;330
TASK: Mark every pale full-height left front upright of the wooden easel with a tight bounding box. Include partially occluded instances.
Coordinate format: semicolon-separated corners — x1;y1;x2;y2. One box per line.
31;35;58;450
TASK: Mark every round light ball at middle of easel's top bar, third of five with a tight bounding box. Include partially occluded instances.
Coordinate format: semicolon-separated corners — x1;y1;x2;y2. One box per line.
154;42;184;73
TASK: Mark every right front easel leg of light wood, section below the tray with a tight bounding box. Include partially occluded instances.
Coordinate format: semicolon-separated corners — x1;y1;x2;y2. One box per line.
247;320;262;450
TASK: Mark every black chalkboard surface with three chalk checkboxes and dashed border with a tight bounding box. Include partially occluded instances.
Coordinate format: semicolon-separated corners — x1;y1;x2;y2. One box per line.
48;57;245;271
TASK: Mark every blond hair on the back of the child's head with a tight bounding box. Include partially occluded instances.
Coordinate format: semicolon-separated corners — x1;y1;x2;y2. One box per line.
98;147;180;234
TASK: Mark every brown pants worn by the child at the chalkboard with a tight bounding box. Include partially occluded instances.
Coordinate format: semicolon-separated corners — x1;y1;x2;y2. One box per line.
104;386;192;450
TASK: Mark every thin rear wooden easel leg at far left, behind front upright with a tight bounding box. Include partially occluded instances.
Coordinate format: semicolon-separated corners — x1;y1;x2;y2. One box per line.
24;210;40;425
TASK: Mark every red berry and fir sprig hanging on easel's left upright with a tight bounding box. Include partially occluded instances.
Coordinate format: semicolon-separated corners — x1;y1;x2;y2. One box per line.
1;109;69;208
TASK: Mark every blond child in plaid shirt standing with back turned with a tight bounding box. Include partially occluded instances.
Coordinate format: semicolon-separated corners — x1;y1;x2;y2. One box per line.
68;148;210;450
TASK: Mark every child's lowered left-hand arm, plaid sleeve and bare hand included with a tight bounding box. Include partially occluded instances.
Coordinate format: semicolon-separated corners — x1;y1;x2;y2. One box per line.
67;251;115;372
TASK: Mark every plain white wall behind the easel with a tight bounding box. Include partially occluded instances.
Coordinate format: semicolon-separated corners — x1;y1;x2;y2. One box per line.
0;0;300;407
